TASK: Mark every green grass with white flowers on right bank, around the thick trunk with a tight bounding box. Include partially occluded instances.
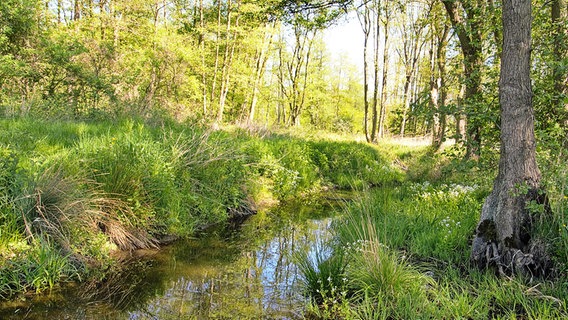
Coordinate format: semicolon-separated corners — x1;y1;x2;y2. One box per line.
302;146;568;319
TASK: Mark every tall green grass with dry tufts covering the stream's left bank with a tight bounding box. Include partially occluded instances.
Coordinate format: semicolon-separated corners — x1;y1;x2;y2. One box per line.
0;118;400;297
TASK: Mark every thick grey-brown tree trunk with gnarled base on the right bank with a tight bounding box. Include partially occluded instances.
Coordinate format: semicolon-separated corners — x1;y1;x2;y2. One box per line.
472;0;548;274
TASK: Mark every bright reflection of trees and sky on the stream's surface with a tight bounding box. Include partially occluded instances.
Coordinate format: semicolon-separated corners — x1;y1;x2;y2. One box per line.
130;199;340;319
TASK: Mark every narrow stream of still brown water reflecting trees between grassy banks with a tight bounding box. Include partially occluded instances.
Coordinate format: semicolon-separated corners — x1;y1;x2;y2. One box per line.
0;196;342;319
